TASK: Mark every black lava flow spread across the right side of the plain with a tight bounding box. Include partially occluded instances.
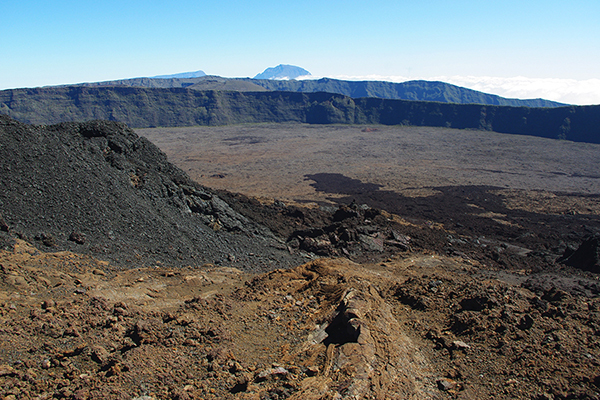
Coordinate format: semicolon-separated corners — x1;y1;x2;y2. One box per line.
305;173;600;252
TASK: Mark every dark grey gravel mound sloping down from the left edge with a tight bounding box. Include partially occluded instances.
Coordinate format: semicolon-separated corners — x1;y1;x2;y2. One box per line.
0;116;300;271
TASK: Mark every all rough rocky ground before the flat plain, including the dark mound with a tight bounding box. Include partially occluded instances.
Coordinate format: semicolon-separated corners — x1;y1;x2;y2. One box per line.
0;119;600;400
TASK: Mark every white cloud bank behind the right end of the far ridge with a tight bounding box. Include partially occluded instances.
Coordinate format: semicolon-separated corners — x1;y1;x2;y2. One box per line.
310;75;600;105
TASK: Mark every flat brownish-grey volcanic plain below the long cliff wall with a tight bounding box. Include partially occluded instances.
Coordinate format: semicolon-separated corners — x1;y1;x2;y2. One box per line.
136;124;600;213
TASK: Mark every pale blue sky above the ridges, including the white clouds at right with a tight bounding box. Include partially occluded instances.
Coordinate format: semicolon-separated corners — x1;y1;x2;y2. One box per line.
0;0;600;104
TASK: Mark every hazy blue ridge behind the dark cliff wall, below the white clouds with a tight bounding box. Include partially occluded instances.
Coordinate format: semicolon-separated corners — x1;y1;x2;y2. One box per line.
245;78;567;107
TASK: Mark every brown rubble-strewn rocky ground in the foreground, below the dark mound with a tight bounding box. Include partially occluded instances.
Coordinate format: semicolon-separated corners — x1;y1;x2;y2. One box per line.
0;240;600;399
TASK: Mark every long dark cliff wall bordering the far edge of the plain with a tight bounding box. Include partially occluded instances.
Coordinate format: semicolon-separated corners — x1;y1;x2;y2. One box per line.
0;87;600;143
